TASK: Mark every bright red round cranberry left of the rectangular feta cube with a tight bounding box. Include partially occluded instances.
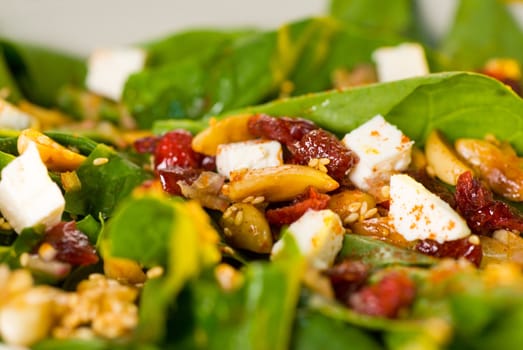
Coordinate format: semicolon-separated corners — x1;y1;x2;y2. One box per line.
154;130;202;170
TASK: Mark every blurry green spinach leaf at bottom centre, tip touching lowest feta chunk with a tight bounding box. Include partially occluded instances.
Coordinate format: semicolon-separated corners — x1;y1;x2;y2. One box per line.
168;231;304;350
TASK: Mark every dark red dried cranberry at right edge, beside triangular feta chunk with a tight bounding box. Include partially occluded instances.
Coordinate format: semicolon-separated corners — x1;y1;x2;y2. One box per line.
455;171;523;235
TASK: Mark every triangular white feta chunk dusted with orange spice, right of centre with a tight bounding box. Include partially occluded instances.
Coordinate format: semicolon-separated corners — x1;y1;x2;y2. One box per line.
389;174;470;243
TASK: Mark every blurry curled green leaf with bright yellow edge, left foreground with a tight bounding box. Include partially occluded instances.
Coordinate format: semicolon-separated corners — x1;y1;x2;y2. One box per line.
102;191;219;343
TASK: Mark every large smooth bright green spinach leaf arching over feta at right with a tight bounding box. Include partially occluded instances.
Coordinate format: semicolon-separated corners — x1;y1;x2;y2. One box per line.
233;72;523;153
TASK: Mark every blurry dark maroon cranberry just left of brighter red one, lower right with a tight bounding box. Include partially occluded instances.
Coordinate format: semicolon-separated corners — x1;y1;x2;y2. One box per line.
325;259;370;304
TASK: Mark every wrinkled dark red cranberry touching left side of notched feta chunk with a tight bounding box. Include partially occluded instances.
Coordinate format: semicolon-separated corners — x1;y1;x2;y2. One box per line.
289;129;359;182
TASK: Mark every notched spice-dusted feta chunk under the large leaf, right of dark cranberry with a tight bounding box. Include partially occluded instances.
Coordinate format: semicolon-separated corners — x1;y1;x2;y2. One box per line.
343;115;414;191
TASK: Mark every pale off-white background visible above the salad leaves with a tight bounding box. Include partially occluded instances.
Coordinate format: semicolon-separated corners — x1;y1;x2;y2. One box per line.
0;0;523;54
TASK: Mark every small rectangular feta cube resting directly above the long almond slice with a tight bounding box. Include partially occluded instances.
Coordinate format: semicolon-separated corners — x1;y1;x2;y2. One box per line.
216;140;283;178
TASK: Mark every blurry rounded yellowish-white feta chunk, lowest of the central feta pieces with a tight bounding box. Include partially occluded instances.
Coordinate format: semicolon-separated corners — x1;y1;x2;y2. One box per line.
271;209;345;269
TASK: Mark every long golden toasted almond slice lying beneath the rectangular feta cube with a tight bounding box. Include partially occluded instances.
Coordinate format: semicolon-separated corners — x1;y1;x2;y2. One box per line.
222;164;339;202
